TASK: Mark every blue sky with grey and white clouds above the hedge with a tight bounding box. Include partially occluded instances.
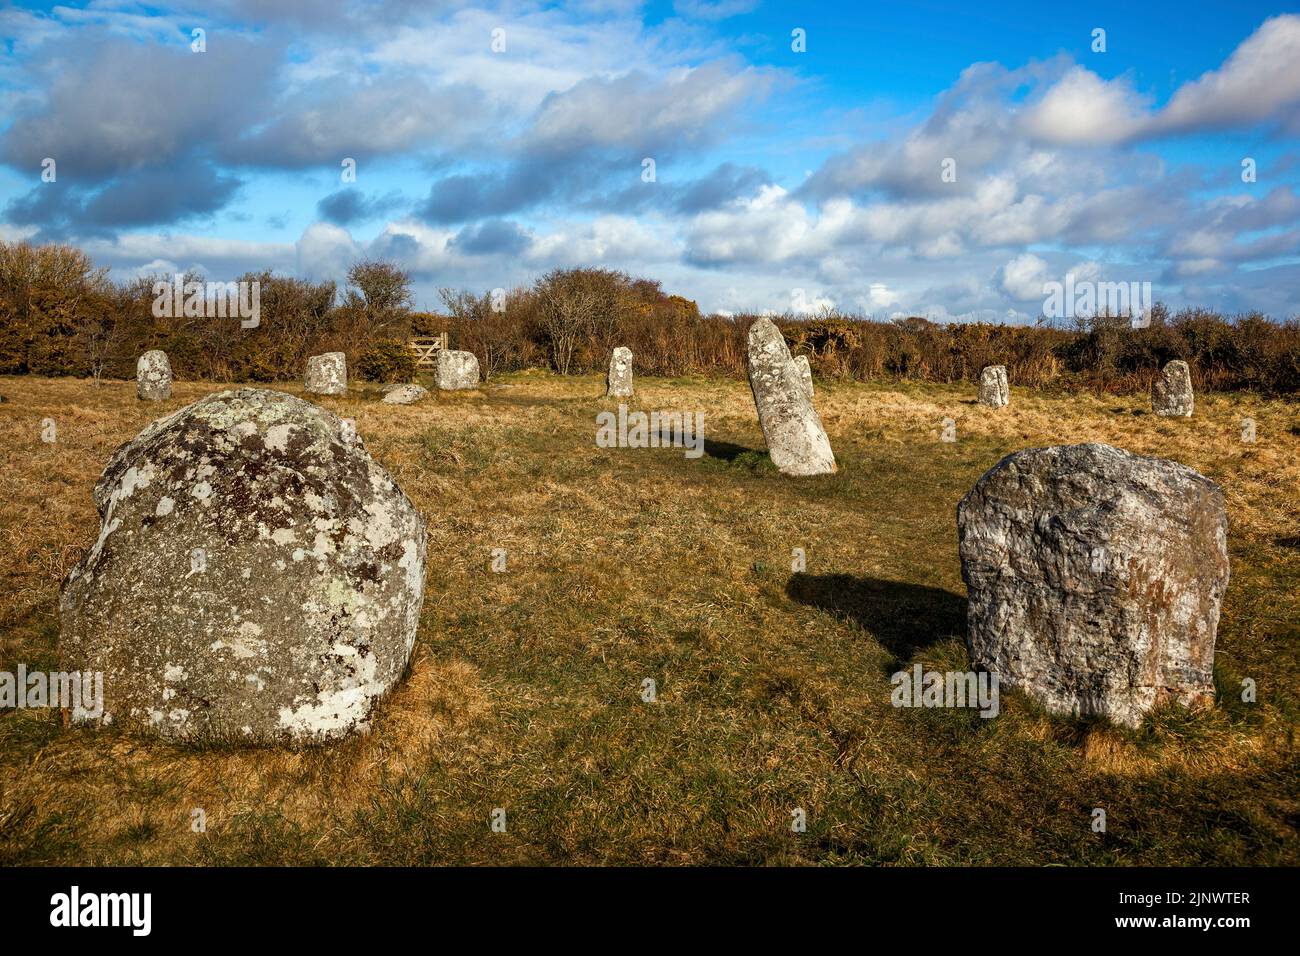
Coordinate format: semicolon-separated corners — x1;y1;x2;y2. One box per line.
0;0;1300;321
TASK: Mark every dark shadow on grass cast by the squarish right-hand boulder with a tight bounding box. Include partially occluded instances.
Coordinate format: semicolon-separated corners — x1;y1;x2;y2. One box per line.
785;574;966;661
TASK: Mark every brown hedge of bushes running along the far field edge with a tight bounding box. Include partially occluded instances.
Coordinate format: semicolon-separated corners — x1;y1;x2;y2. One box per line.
0;242;1300;394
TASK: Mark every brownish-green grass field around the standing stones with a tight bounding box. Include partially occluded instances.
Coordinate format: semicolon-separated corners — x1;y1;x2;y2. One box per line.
0;373;1300;865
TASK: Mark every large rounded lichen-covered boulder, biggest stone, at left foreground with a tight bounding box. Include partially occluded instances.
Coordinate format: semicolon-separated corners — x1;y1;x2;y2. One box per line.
60;389;425;744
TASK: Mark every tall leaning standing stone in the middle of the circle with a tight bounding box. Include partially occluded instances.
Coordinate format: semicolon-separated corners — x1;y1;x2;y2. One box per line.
749;317;835;475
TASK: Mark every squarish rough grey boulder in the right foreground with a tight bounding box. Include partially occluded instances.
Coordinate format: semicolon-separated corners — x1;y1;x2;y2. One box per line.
957;444;1229;727
